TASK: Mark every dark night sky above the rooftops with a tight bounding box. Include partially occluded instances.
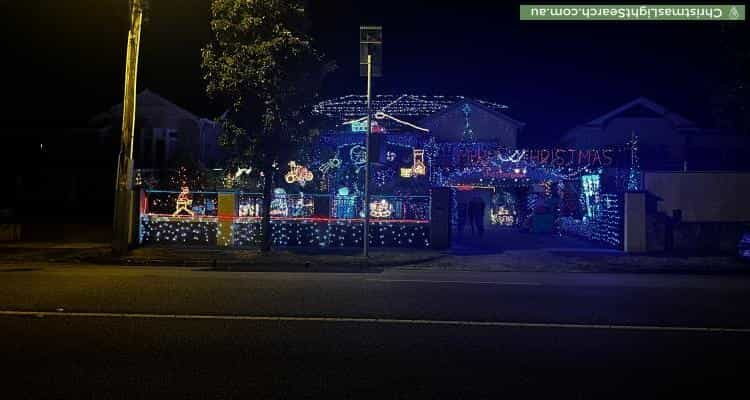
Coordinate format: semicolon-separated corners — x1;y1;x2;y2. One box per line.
0;0;747;142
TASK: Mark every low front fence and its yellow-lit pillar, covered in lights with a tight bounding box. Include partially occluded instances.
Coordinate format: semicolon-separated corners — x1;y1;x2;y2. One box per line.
140;187;430;248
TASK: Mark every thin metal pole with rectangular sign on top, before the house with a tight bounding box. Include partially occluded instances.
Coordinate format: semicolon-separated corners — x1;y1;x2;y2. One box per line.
359;26;383;258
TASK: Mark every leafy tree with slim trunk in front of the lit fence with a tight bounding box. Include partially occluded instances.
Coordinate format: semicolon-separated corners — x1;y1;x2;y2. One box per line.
202;0;334;252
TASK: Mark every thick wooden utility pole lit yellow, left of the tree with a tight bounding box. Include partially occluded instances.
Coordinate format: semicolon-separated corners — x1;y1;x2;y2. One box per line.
112;0;143;255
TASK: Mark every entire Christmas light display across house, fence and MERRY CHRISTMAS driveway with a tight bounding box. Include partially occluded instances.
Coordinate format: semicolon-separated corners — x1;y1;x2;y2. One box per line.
138;95;640;252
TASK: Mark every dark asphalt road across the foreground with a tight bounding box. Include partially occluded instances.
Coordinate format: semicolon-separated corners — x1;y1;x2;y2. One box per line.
0;265;750;399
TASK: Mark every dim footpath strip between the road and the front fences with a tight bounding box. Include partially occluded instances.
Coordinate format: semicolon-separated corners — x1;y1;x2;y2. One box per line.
0;242;750;274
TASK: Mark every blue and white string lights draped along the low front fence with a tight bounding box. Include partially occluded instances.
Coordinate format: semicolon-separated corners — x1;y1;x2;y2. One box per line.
140;187;430;247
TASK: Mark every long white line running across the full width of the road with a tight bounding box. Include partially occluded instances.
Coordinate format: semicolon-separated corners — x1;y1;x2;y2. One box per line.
0;310;750;334
